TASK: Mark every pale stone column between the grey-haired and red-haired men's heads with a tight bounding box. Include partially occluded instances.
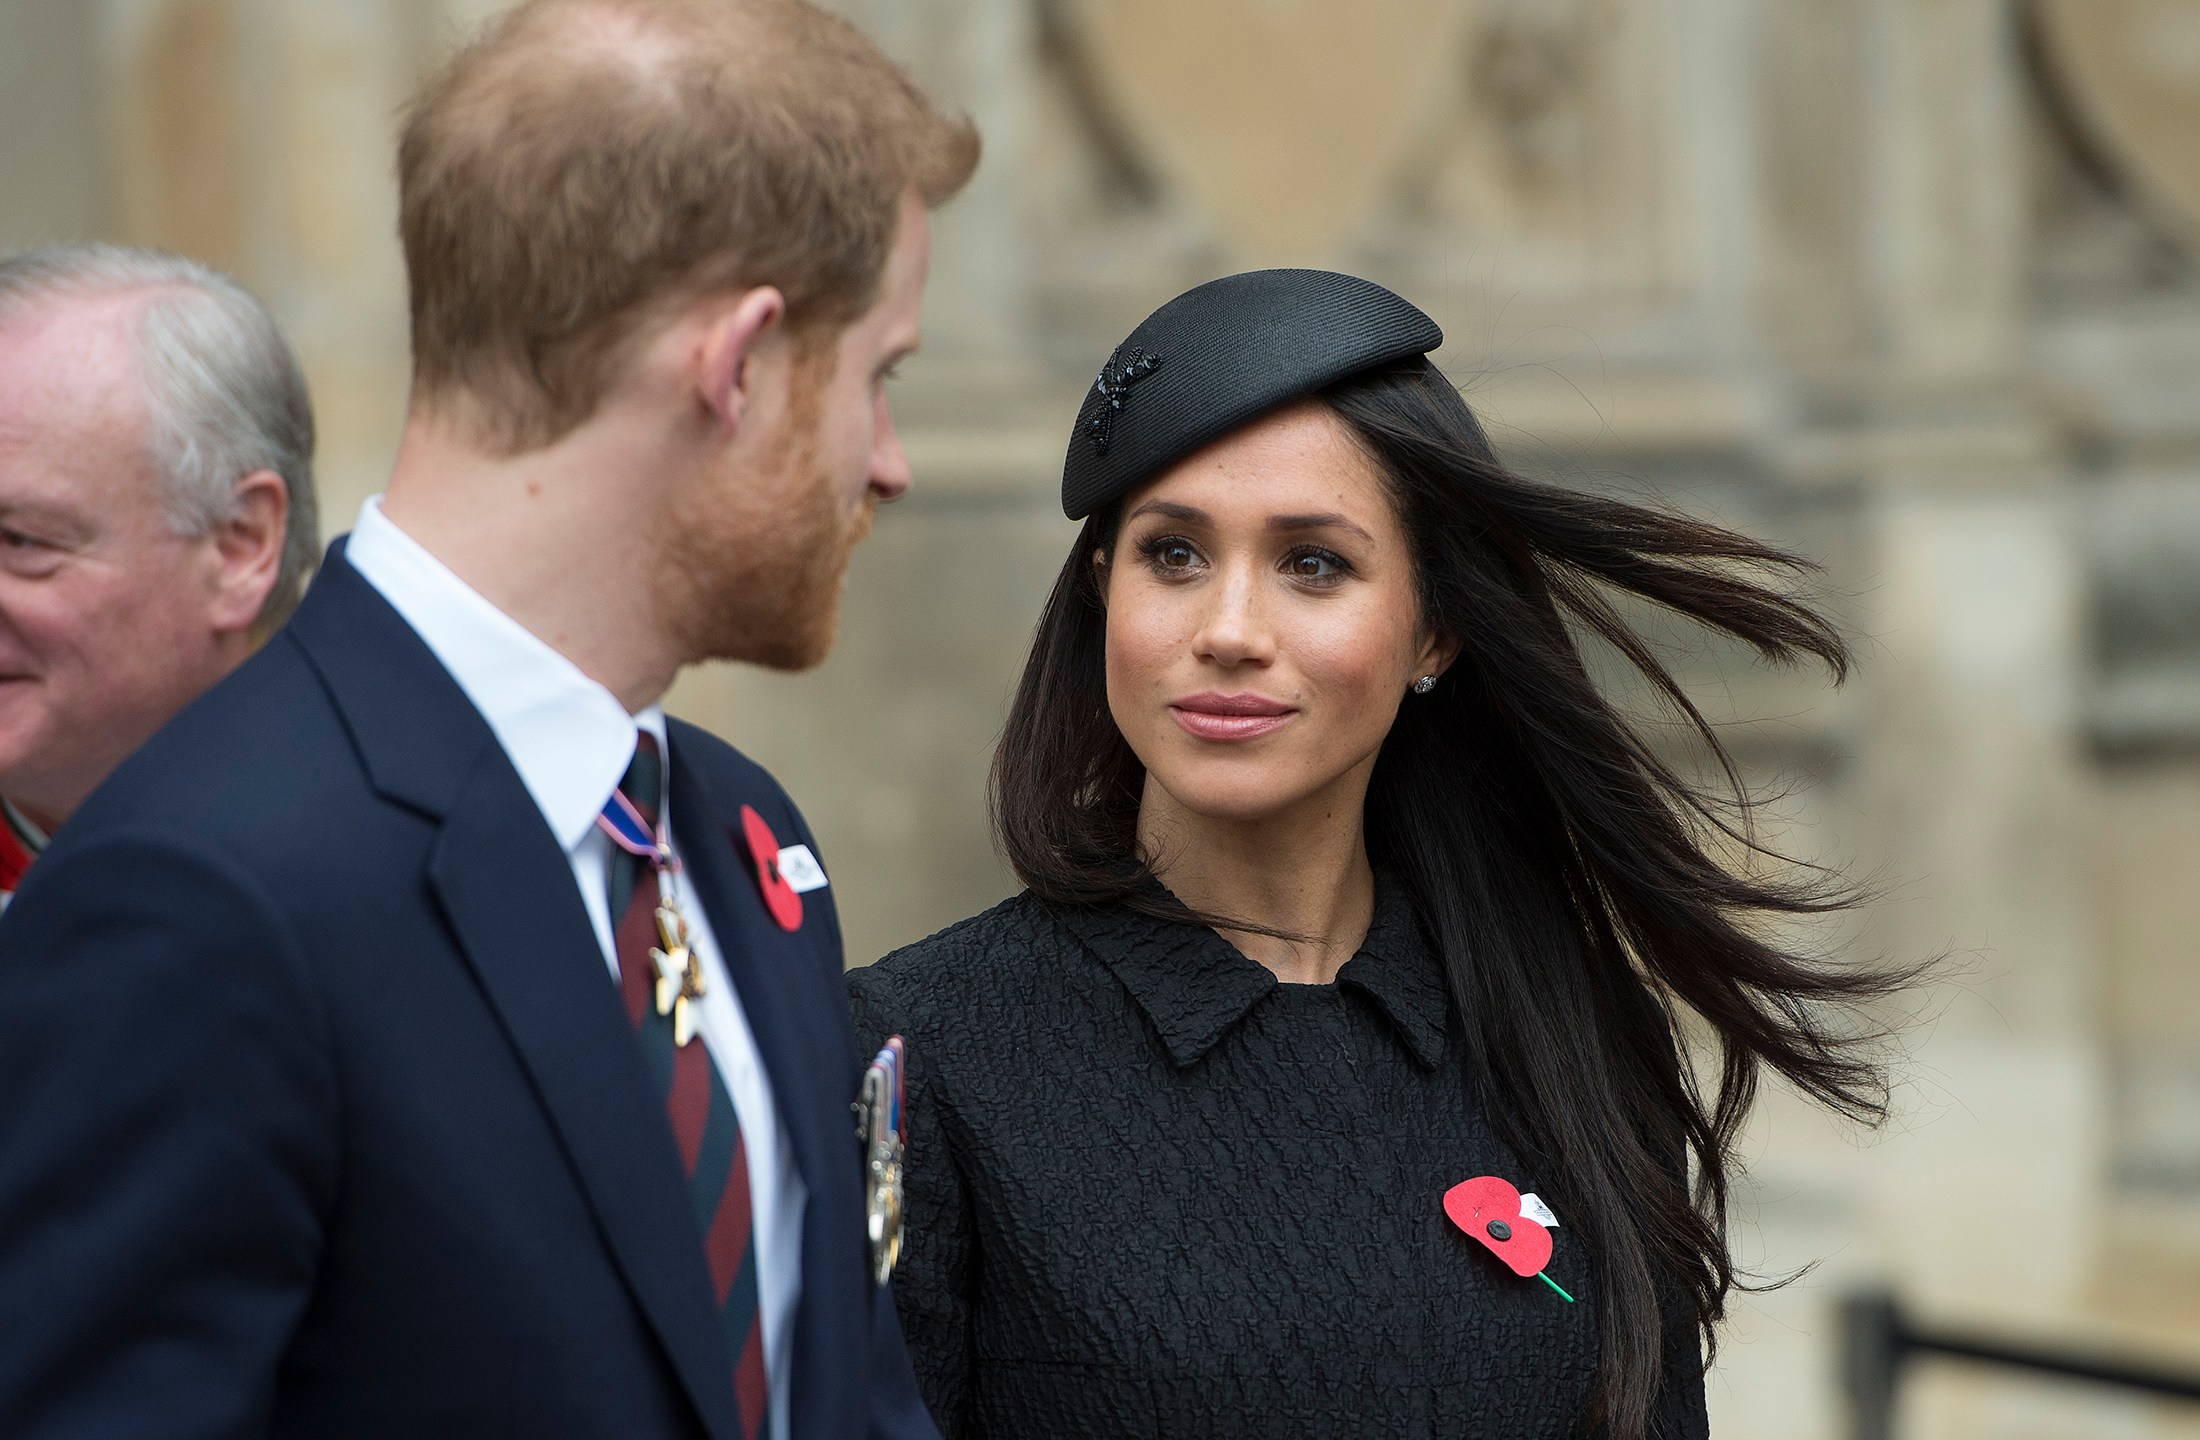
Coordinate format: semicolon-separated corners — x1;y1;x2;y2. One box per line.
99;0;420;532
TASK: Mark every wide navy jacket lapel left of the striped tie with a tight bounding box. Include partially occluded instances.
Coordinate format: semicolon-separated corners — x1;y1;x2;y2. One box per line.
293;558;739;1440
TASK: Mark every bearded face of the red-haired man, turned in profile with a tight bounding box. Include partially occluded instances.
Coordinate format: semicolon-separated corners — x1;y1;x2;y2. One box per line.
658;193;931;671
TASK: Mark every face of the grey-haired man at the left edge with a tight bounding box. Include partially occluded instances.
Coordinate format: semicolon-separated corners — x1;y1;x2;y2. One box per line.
0;297;238;827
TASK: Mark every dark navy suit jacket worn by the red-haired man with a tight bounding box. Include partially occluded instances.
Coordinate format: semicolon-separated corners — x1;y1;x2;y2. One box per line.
0;543;935;1440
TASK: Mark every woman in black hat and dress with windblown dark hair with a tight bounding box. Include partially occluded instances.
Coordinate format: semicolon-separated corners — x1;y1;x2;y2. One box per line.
849;270;1899;1440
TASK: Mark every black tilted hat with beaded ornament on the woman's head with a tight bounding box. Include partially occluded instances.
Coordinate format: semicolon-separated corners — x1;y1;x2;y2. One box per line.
1063;270;1443;521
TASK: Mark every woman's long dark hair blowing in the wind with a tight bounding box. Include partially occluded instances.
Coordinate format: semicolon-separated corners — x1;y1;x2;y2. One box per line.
992;358;1910;1440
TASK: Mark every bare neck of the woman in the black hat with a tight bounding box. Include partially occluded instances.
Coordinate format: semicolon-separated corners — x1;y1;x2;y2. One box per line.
1137;776;1375;985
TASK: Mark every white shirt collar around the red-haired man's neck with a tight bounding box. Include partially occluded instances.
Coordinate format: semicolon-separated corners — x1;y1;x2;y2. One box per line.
343;497;669;851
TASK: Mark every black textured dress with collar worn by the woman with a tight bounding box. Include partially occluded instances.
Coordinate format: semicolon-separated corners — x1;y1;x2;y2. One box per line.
849;886;1707;1440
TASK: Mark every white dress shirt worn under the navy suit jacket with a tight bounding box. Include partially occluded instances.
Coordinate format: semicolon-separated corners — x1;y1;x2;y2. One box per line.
343;497;810;1440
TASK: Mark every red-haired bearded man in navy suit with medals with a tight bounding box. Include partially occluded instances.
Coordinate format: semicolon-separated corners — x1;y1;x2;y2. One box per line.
0;0;977;1440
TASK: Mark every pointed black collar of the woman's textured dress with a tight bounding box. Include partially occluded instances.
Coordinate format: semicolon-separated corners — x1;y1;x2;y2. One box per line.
1049;875;1450;1068
